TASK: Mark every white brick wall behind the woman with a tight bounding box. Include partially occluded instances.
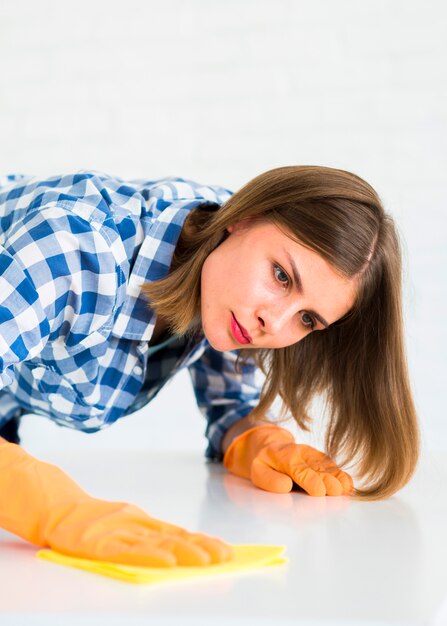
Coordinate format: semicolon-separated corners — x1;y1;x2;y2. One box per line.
0;0;447;451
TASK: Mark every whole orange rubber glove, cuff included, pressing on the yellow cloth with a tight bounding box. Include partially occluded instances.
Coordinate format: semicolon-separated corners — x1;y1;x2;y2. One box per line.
0;438;232;567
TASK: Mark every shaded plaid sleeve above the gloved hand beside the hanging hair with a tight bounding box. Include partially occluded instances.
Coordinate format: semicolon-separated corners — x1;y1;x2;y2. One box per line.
188;346;270;461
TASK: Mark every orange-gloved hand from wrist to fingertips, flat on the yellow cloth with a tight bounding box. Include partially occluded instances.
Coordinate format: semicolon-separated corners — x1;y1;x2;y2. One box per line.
43;497;231;567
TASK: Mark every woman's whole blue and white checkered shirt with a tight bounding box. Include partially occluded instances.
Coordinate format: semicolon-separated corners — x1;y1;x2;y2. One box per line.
0;171;266;459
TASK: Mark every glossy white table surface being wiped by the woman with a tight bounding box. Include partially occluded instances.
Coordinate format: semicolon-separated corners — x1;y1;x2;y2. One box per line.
0;450;447;626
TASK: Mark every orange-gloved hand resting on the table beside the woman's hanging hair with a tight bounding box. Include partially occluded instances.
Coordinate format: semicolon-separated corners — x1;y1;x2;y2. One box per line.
223;424;354;496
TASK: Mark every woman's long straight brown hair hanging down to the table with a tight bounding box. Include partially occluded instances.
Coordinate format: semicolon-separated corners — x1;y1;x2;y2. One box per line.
143;166;420;500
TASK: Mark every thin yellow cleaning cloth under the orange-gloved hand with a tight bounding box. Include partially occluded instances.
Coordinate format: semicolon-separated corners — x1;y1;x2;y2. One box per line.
37;545;287;585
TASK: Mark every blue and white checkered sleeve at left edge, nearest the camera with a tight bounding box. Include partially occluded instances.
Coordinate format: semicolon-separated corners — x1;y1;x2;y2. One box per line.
0;202;117;389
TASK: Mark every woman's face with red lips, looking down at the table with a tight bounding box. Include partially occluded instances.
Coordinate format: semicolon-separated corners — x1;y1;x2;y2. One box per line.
201;221;356;352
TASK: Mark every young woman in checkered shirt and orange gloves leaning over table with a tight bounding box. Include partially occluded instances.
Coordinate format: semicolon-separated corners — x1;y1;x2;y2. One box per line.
0;166;419;566
